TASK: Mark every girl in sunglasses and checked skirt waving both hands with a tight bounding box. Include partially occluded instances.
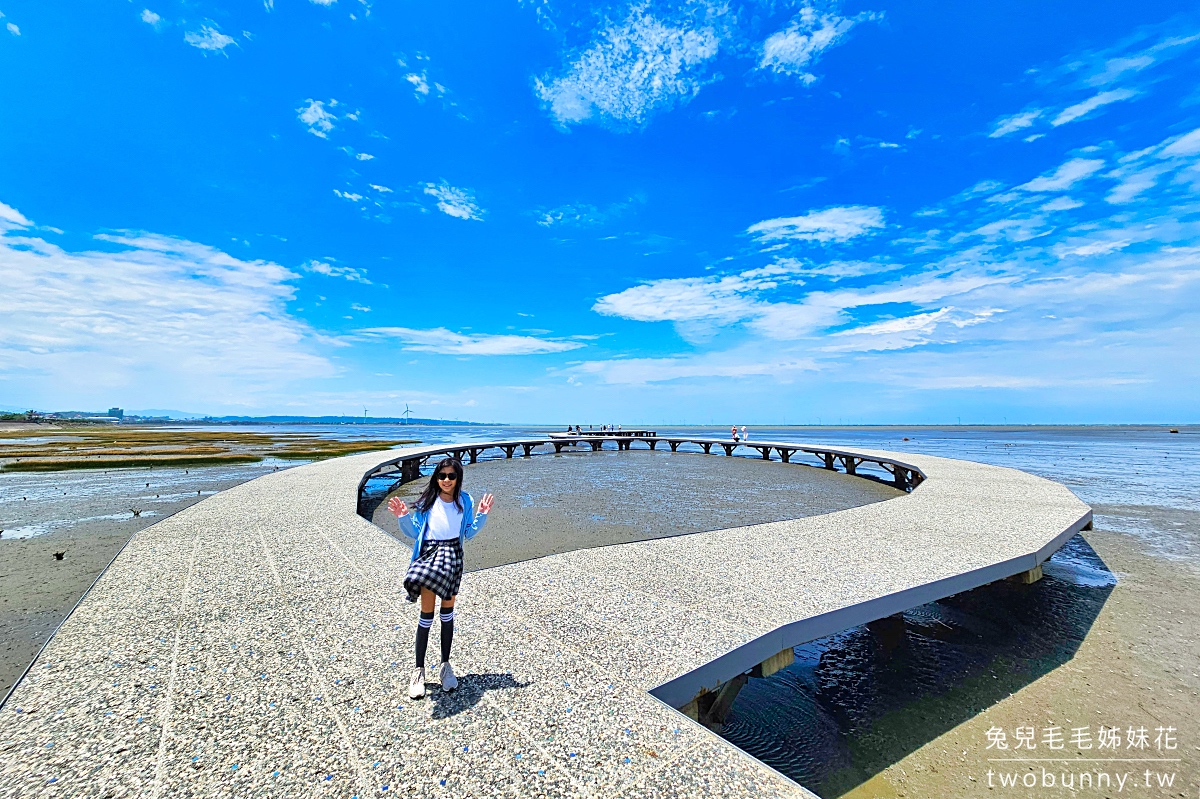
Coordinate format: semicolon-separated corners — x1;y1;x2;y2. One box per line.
388;458;492;699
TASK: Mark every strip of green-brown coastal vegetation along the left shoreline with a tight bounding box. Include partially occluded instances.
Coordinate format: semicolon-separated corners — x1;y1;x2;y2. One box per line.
0;425;418;471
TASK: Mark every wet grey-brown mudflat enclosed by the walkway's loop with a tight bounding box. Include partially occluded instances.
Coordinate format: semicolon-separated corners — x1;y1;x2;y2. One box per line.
371;451;904;571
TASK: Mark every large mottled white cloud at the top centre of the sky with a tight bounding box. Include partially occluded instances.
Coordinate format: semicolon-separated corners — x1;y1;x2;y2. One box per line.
534;5;725;126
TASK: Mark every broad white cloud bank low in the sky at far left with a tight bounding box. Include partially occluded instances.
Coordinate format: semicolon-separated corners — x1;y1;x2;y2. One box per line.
0;214;335;404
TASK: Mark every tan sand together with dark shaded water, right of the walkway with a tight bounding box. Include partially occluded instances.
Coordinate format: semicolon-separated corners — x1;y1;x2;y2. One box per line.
724;515;1200;799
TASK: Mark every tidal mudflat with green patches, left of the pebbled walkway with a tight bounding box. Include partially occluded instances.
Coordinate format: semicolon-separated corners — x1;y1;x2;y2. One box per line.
0;423;413;698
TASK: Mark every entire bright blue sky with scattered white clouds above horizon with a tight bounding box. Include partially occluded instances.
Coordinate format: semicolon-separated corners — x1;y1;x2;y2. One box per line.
0;0;1200;425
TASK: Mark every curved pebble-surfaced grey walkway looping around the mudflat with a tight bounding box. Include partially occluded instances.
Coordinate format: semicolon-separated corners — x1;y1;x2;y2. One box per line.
0;441;1091;798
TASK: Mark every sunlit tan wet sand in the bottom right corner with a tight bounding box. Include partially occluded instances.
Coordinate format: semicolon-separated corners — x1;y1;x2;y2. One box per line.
822;529;1200;799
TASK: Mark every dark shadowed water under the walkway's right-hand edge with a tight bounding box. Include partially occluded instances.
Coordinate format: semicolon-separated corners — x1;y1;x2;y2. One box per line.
721;527;1116;797
